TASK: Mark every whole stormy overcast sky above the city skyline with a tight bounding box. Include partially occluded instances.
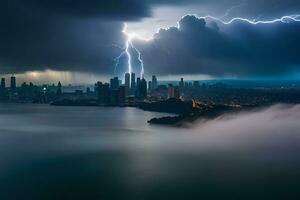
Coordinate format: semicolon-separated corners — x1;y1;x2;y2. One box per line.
0;0;300;83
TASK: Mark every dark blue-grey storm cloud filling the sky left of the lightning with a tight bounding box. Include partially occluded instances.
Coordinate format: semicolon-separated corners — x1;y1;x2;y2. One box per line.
0;0;140;73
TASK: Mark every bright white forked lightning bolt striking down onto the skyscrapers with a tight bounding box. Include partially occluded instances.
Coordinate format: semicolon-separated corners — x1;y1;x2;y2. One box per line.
114;23;146;78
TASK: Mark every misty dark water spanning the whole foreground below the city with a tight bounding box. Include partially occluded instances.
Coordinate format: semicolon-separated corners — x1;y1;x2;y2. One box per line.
0;104;300;200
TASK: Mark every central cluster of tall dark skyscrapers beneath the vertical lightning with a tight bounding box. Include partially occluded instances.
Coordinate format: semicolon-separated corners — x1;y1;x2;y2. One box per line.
95;73;206;105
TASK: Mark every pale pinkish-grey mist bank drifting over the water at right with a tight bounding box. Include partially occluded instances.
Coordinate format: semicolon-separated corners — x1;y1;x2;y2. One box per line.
164;104;300;152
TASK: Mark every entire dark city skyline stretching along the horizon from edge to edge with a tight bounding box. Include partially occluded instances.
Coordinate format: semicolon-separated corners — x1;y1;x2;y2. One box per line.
0;73;300;107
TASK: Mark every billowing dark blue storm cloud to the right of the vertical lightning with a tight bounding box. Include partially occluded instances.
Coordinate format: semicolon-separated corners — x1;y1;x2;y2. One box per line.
136;16;300;76
